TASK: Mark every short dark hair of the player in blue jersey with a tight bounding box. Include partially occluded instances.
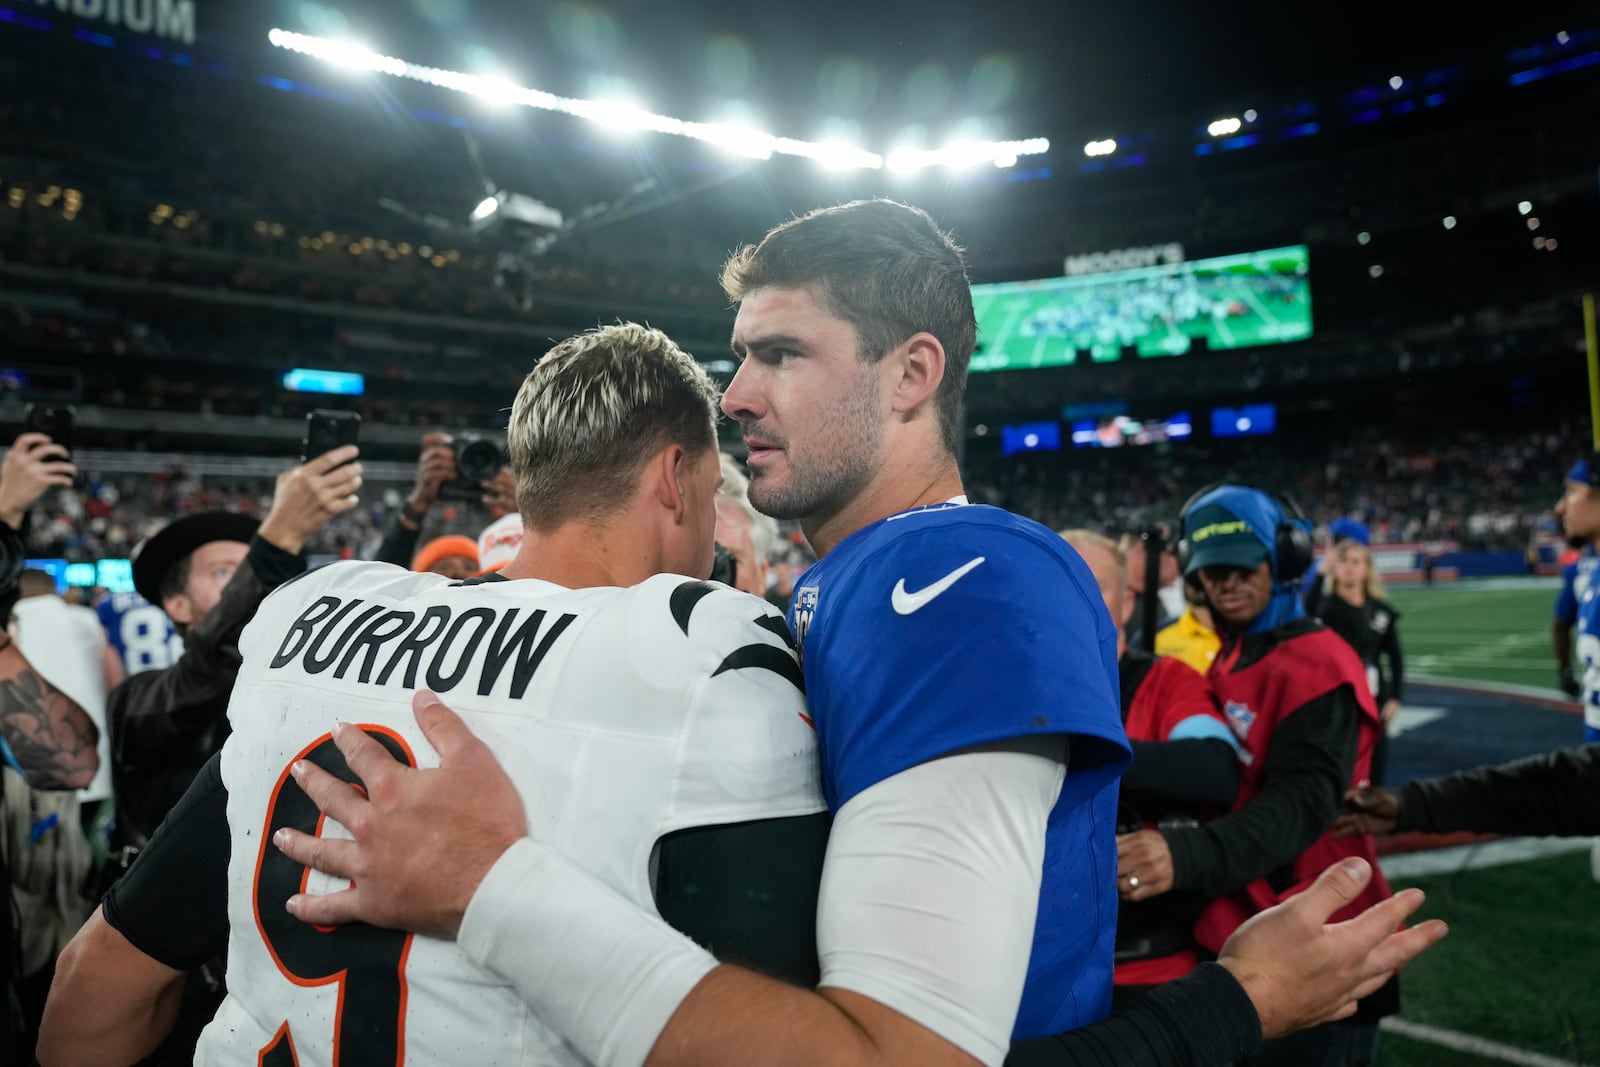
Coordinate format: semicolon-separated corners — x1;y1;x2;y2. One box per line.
722;200;978;456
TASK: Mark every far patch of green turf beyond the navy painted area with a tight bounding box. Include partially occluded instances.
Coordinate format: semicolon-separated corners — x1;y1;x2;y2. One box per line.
1389;581;1555;688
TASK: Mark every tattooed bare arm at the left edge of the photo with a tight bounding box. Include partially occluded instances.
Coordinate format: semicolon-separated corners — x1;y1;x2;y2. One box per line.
0;633;99;789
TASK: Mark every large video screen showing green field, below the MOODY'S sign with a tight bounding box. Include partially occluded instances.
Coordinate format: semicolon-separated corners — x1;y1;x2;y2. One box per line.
971;245;1312;371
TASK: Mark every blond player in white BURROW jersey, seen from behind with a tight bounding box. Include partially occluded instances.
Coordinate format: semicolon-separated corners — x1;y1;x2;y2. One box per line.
38;325;827;1067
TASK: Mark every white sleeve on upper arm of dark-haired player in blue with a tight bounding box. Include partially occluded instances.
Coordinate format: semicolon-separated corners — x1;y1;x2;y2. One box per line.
816;737;1066;1064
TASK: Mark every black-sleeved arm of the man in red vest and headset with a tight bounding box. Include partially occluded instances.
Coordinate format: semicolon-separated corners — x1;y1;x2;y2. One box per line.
1162;686;1362;896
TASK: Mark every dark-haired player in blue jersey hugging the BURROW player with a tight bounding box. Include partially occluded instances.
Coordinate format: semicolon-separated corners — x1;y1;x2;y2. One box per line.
275;200;1440;1067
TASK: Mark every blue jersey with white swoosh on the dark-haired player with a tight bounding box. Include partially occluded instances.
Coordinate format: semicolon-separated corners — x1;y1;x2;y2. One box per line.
789;504;1130;1037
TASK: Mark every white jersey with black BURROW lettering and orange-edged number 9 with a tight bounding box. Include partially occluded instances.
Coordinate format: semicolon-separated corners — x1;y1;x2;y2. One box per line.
195;563;826;1067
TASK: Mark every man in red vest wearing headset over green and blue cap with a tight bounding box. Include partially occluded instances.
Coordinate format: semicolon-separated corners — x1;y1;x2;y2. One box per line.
1117;485;1398;1067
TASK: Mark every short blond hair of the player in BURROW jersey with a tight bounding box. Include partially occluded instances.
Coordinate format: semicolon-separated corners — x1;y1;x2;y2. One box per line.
506;323;718;531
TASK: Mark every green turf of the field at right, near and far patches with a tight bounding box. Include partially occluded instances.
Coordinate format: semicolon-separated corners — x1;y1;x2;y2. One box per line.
1344;579;1600;1067
